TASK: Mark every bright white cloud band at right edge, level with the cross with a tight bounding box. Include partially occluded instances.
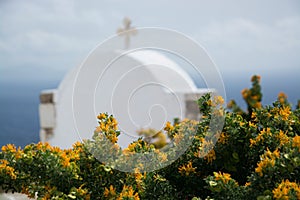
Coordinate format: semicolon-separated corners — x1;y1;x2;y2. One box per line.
198;17;300;52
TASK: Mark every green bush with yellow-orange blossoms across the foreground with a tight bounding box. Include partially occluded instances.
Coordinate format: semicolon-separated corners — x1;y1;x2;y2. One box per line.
0;76;300;200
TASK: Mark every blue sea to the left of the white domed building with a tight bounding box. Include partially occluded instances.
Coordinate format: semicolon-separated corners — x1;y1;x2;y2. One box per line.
0;82;58;147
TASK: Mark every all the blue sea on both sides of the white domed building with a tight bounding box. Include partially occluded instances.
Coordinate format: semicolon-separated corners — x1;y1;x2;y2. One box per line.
0;73;300;147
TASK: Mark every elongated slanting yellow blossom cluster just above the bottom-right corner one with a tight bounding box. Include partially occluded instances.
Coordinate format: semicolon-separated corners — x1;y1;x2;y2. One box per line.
255;148;280;176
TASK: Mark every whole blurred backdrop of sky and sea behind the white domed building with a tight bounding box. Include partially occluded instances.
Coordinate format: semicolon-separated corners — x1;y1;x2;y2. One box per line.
0;0;300;146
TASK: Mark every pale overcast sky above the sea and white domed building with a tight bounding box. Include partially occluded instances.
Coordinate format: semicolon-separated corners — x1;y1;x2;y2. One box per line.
0;0;300;83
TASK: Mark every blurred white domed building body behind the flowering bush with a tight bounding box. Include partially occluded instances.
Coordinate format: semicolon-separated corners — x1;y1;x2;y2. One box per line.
49;50;197;148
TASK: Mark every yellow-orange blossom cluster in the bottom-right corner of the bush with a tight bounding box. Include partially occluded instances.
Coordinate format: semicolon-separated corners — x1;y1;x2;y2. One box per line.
272;180;300;200
